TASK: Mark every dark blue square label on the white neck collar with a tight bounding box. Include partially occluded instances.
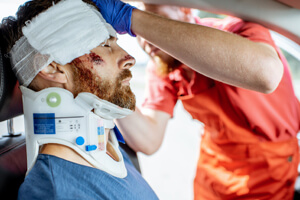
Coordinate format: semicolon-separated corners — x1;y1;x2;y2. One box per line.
33;113;55;134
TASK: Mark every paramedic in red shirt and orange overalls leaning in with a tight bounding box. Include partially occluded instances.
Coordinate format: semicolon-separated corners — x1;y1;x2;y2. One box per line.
94;0;300;200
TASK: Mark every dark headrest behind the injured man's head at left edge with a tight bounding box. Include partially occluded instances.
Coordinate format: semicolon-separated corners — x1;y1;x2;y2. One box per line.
0;26;23;122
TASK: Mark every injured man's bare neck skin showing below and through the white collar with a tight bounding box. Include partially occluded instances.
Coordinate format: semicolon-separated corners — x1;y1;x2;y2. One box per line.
40;129;118;167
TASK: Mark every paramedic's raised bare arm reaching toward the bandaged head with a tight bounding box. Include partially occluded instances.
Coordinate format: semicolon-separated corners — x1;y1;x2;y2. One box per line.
131;9;283;93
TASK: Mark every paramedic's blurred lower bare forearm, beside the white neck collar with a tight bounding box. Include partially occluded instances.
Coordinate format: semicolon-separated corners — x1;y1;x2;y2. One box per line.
116;108;171;155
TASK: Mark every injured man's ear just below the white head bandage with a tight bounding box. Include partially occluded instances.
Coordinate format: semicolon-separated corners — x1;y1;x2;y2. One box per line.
38;62;67;84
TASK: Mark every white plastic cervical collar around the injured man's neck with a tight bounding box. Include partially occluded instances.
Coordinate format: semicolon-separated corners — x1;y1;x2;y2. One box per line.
20;86;132;178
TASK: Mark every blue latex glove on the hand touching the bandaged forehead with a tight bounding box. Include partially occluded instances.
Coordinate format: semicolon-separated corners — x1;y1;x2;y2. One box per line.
93;0;136;36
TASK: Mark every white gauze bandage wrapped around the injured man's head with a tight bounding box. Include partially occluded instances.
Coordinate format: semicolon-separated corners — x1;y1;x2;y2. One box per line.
10;0;116;87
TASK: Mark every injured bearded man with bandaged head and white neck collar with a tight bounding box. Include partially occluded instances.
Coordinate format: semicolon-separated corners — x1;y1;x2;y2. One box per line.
1;0;157;200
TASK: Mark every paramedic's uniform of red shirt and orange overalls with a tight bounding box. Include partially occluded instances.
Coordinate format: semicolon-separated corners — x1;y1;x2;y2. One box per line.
143;17;300;200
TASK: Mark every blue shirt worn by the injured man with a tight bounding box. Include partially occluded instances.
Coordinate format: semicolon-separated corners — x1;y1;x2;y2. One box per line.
18;149;158;200
